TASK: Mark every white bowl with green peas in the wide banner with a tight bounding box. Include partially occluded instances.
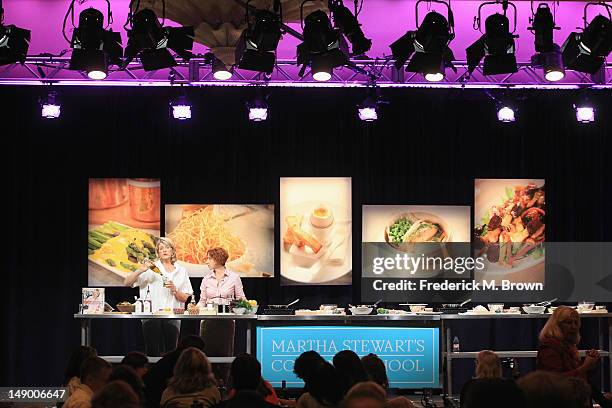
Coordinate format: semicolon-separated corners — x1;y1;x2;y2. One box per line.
385;212;451;253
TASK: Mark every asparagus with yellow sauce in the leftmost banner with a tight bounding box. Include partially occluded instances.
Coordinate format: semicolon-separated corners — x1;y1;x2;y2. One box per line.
87;221;158;278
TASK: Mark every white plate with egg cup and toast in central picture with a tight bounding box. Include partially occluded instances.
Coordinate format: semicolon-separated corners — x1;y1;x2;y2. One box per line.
281;201;352;283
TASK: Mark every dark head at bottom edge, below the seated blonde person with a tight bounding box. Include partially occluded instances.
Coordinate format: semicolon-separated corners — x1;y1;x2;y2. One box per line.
461;378;525;408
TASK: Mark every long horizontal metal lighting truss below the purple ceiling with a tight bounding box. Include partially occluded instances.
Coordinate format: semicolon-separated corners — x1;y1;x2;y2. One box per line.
0;54;612;89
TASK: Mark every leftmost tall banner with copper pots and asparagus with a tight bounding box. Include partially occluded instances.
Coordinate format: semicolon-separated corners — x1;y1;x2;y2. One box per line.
87;178;161;286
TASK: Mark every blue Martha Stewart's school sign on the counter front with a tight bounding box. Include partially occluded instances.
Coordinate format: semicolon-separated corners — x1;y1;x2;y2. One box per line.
256;326;440;388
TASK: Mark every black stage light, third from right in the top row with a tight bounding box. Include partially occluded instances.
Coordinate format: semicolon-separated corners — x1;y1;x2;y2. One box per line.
466;0;518;75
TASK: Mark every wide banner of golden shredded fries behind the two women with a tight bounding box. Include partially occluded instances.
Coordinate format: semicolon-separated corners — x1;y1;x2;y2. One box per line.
165;204;274;278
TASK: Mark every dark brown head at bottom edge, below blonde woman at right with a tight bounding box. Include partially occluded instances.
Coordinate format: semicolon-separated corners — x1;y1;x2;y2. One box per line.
517;371;582;408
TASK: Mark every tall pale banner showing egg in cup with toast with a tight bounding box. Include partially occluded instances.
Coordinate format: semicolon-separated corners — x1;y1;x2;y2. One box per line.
280;177;353;285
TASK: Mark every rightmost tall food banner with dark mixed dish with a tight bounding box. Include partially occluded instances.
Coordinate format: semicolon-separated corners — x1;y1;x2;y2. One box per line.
474;180;546;282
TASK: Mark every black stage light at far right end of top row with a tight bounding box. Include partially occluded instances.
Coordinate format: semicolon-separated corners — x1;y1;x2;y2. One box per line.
561;2;612;74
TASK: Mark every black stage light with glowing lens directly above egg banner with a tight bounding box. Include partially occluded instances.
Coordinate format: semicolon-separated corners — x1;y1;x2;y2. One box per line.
297;10;349;81
